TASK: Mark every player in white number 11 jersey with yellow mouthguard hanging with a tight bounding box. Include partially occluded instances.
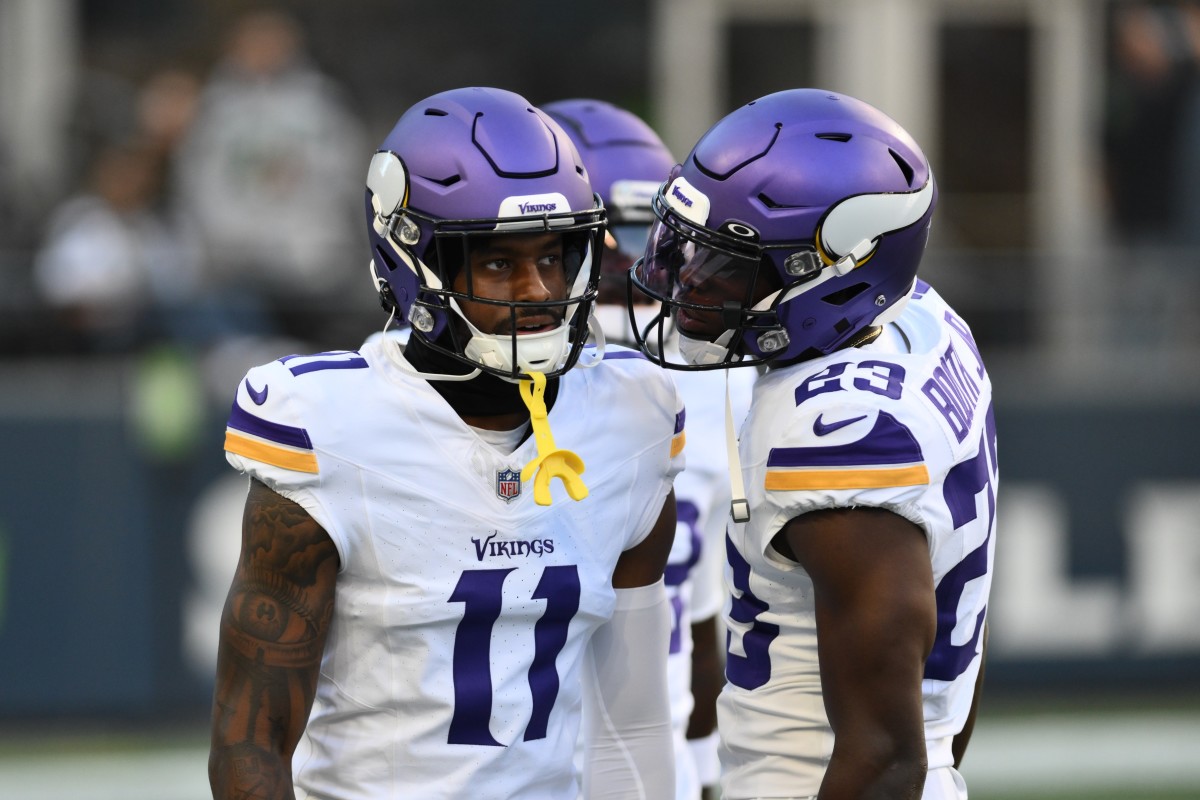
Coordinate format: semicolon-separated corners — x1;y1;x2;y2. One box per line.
209;88;684;800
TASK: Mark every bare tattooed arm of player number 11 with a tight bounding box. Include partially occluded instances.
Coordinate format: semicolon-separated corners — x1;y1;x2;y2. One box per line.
209;480;338;800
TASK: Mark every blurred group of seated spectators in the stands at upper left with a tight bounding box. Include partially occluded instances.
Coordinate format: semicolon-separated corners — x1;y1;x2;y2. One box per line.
2;11;376;355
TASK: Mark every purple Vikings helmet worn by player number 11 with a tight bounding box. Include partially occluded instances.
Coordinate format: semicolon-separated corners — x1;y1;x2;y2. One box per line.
366;88;605;379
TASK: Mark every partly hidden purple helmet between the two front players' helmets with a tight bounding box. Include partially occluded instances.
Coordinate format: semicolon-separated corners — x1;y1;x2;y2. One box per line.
541;100;676;345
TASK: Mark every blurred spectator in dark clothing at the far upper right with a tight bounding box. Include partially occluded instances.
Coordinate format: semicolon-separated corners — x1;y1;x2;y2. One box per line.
1103;0;1200;348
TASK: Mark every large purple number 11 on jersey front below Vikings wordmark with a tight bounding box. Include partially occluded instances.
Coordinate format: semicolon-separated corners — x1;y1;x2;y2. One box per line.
448;565;580;747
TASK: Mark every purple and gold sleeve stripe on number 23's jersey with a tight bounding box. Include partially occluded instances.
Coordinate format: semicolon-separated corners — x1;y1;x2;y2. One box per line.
766;411;929;492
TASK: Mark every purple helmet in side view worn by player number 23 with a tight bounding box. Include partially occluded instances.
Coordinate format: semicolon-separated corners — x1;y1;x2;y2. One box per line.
630;89;937;369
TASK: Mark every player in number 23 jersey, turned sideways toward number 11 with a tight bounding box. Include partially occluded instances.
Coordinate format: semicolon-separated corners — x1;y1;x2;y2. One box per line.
630;89;997;800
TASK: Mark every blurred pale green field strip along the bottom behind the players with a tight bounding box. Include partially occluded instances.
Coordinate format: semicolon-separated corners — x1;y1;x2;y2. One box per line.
0;698;1200;800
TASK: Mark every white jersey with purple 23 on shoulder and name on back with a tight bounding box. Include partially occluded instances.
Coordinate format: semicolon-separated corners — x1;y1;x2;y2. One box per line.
718;282;997;800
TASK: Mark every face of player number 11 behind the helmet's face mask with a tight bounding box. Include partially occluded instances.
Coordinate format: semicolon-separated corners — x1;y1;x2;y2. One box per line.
454;233;566;336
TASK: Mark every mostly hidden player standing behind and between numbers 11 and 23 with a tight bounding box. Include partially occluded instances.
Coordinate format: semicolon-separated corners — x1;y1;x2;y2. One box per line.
541;98;755;800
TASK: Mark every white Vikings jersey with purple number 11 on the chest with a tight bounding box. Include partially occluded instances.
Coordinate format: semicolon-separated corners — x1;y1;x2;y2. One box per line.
226;337;684;800
